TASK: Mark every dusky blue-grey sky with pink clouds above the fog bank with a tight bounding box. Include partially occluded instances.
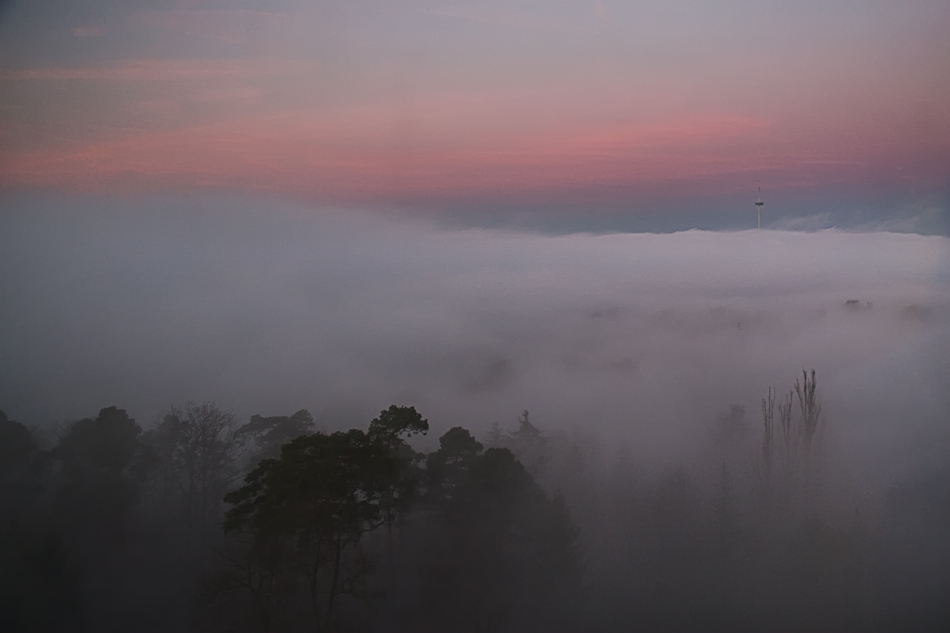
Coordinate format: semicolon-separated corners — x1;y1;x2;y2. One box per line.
0;0;950;234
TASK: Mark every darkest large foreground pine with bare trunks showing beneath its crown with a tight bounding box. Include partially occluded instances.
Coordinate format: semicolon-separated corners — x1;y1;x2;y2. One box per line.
224;429;396;631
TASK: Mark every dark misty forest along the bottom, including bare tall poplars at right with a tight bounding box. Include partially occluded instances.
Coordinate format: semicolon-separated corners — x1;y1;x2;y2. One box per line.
0;372;950;633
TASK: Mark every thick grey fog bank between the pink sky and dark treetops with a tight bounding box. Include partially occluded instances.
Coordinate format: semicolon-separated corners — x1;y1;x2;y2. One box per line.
0;195;950;476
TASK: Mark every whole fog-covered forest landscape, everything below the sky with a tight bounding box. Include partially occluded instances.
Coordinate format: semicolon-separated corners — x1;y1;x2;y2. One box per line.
0;208;950;632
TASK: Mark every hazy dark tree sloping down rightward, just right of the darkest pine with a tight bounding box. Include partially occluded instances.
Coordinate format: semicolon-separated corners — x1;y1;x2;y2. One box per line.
424;427;582;631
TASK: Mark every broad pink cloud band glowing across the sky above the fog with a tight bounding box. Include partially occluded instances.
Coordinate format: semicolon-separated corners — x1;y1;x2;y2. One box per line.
0;60;947;200
